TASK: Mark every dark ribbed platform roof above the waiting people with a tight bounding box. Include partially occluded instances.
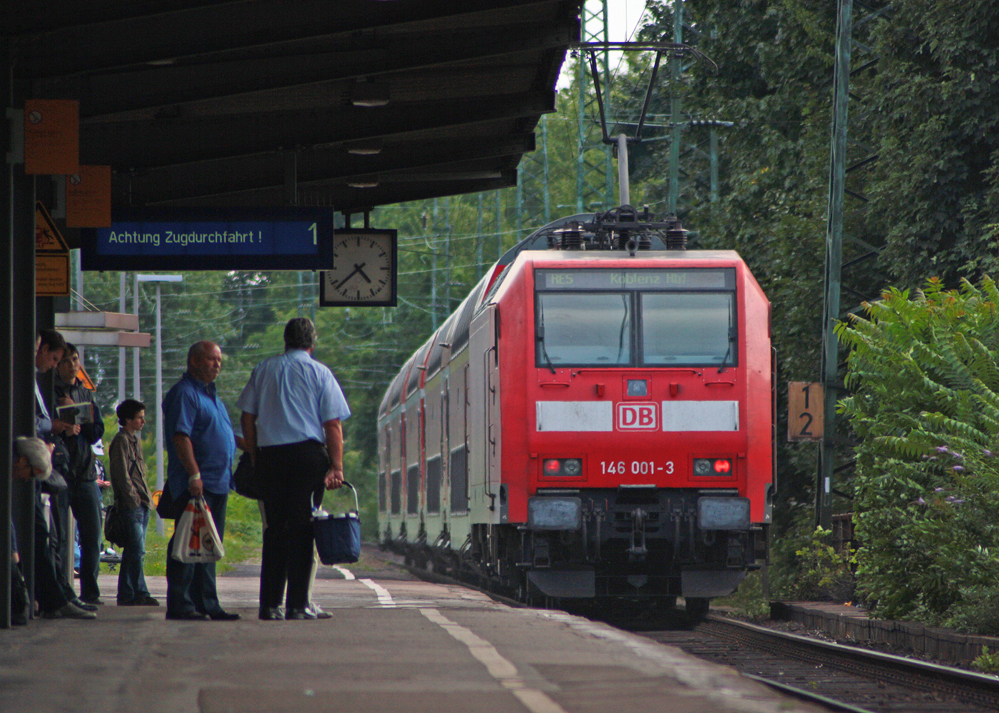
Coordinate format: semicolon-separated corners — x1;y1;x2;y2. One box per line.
7;0;581;213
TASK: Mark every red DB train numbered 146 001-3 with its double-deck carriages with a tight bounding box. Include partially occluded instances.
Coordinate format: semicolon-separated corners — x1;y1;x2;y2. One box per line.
378;206;774;612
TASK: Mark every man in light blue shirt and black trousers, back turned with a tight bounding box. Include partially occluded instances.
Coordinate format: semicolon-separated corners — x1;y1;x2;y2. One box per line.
236;317;350;620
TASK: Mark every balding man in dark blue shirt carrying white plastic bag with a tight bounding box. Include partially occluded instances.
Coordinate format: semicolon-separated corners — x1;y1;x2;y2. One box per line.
163;341;239;621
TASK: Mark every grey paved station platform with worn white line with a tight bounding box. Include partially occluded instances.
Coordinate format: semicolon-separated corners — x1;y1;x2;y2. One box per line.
0;553;821;713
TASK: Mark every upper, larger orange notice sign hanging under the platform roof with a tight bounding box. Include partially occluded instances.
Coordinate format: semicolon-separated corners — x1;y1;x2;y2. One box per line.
24;99;80;176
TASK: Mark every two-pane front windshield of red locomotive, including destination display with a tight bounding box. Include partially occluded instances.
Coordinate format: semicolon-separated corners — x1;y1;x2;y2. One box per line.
535;268;738;368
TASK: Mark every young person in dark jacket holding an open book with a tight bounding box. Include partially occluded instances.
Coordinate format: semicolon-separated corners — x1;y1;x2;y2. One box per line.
52;342;104;604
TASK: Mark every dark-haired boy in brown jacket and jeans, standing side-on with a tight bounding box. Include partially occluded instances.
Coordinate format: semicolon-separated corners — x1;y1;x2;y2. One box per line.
108;399;159;607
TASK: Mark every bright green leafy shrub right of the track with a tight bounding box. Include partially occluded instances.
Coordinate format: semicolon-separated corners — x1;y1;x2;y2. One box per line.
837;278;999;623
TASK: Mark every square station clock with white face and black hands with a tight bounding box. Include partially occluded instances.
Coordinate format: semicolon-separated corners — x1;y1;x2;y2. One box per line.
319;229;396;306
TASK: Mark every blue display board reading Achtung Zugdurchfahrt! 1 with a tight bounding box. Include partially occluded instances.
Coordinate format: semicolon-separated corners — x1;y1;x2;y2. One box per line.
80;207;333;270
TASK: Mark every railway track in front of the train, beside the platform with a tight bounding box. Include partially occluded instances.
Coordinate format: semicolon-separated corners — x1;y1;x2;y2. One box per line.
624;617;999;713
